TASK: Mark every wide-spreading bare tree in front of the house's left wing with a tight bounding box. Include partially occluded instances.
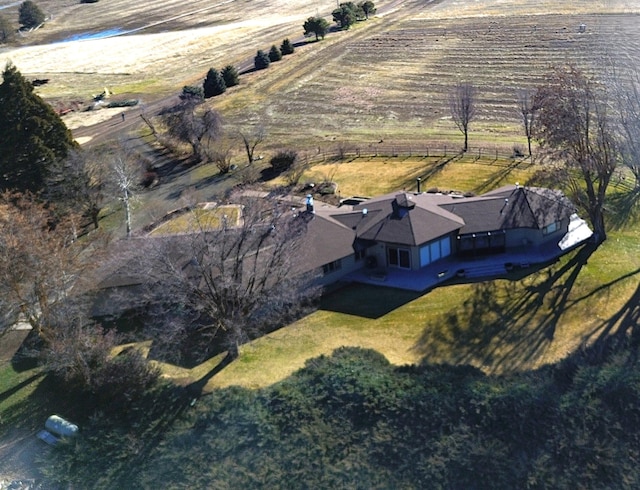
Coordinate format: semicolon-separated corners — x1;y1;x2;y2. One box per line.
143;196;318;359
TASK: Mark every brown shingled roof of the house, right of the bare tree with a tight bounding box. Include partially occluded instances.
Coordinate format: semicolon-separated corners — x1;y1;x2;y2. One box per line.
307;185;575;267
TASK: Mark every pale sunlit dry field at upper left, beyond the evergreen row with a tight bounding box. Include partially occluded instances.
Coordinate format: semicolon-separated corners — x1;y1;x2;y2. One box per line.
0;0;324;97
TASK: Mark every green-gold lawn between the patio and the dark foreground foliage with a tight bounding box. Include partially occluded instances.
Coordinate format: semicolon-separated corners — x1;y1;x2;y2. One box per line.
208;226;640;389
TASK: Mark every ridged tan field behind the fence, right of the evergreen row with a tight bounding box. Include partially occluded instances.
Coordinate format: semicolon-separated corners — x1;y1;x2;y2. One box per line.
213;2;640;151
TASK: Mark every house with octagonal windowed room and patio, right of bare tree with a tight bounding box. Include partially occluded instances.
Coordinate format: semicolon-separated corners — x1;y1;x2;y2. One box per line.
306;184;592;291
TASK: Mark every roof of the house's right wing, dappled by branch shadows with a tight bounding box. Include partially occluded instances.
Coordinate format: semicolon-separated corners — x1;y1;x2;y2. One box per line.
441;185;575;234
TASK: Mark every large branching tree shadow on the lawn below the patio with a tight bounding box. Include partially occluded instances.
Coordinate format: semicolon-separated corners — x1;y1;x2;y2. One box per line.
415;244;595;372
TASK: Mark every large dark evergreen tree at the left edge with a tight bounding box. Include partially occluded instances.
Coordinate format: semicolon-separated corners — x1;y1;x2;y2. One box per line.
0;64;76;192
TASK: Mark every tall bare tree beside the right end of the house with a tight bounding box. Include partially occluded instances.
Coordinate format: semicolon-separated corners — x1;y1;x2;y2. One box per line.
535;66;619;241
